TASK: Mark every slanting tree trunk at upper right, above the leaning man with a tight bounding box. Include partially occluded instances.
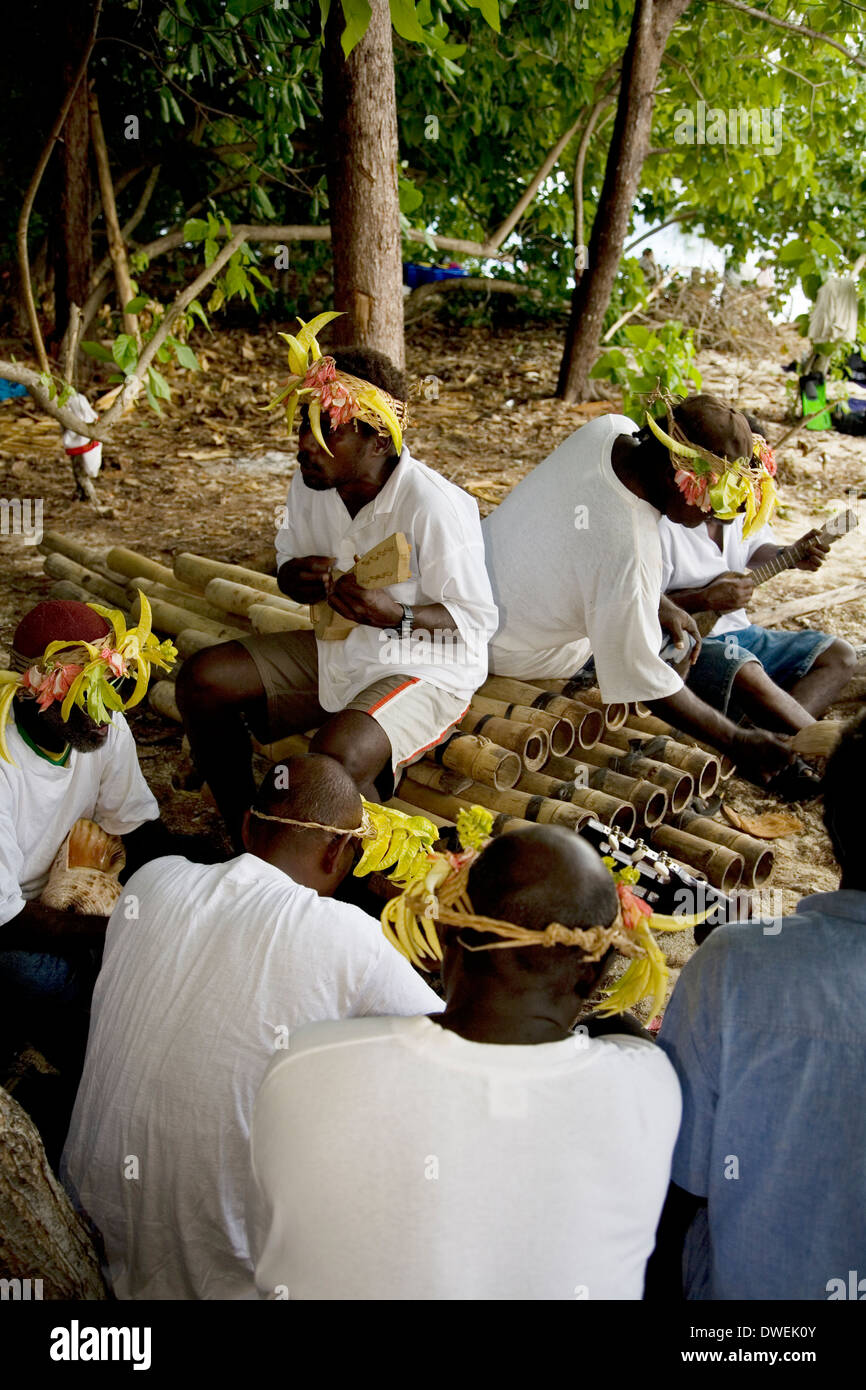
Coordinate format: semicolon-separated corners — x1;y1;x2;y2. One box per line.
556;0;691;402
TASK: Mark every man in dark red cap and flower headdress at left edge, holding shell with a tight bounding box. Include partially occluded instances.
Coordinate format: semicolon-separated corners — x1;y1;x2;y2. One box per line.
0;600;174;1084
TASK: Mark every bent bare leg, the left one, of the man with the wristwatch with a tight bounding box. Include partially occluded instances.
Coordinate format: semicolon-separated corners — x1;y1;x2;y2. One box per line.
177;642;267;852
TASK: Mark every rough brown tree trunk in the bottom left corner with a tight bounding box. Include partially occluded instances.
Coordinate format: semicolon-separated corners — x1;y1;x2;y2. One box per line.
0;1087;106;1301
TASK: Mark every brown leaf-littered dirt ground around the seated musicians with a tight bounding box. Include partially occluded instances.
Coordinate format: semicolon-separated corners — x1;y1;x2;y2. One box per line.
0;311;866;910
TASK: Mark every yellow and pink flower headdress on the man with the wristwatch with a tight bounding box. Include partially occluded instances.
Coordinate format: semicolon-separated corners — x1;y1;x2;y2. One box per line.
268;310;406;453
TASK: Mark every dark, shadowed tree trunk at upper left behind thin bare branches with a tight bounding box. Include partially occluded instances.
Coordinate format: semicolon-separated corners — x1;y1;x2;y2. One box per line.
51;0;93;342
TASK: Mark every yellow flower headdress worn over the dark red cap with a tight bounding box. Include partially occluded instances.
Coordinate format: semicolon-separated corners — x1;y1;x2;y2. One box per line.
0;589;178;763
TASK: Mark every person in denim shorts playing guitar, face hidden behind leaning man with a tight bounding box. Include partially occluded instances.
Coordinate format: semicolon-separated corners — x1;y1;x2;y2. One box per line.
659;517;856;733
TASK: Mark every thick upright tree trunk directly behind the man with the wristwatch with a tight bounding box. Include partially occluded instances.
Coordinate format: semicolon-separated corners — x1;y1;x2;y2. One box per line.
322;0;405;367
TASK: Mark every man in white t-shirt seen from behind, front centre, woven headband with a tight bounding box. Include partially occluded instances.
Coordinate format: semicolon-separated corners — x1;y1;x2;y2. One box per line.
249;826;680;1301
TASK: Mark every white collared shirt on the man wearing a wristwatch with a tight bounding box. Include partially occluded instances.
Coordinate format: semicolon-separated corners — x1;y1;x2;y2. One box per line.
277;448;496;710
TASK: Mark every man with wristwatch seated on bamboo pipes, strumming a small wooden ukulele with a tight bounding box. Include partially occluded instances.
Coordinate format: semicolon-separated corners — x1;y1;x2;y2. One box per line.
178;349;496;841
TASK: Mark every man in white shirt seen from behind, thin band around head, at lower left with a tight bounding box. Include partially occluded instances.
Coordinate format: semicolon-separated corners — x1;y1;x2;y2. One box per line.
63;755;441;1298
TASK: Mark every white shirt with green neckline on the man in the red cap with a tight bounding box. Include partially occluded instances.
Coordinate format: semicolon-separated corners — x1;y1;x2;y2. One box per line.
0;713;160;923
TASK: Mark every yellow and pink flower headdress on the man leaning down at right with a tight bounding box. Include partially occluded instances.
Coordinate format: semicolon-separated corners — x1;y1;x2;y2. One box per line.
646;392;777;537
